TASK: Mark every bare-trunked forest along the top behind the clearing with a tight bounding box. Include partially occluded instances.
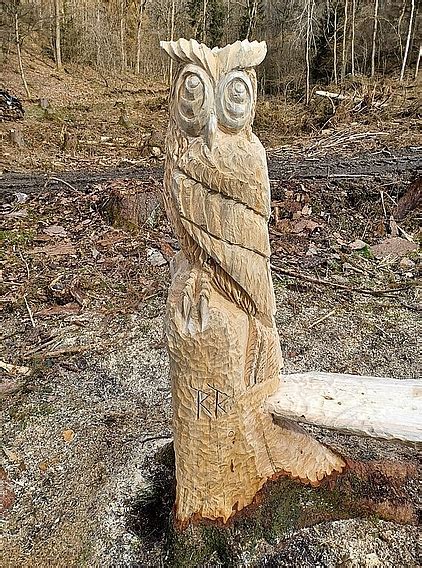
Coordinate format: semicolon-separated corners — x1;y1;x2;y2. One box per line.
2;0;421;102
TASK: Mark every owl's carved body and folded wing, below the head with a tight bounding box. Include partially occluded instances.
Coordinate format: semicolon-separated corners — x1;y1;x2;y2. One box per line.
171;133;275;318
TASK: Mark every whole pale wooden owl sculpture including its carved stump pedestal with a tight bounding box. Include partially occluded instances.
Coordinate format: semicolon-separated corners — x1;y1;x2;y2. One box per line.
161;39;344;523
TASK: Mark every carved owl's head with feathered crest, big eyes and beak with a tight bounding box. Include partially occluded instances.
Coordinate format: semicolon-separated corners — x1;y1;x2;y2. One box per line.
160;39;267;148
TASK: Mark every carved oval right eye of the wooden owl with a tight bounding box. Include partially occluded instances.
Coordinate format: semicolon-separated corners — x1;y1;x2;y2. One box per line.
217;71;253;130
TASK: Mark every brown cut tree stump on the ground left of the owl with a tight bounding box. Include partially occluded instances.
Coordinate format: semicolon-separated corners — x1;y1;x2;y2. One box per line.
102;180;160;233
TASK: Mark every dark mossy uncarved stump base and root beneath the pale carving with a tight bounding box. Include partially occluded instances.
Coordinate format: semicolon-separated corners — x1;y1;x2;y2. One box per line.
130;443;417;568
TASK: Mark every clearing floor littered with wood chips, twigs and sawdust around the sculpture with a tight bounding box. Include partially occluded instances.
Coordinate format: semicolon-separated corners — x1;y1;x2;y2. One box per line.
0;52;422;568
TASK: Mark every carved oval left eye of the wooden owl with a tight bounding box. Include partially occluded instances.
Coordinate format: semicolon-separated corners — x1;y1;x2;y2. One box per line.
176;65;213;136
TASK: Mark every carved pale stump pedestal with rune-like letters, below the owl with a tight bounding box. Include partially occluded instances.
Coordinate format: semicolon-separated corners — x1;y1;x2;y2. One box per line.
166;253;345;525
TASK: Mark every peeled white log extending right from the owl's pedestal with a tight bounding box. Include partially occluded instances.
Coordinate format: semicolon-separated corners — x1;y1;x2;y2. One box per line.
266;372;422;443
